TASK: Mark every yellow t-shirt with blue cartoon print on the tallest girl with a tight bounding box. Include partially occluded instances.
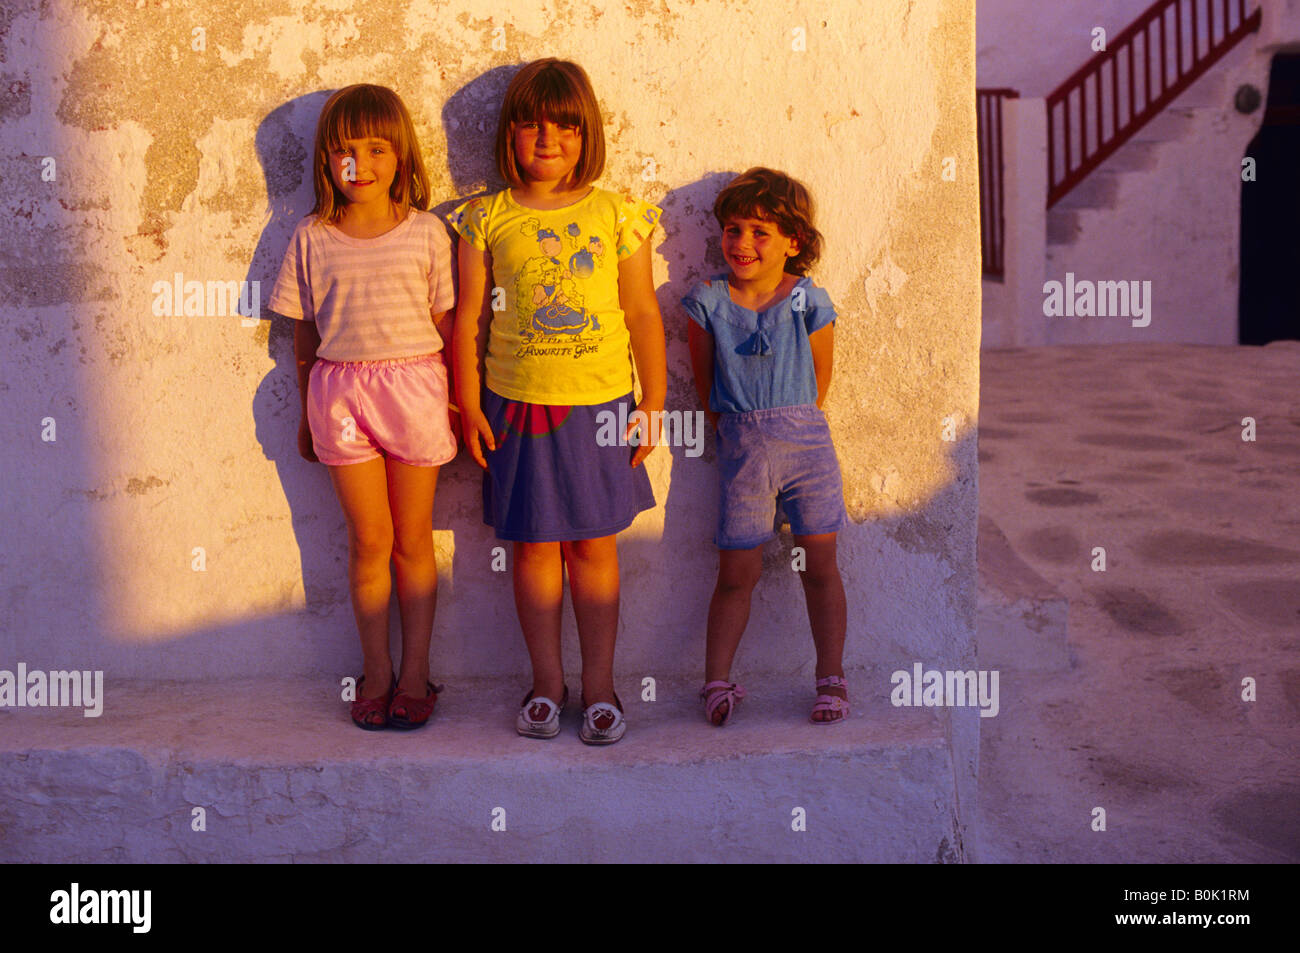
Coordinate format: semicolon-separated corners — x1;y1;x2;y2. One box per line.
447;189;662;406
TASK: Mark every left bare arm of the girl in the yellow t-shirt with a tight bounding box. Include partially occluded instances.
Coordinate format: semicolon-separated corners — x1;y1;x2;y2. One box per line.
451;238;497;468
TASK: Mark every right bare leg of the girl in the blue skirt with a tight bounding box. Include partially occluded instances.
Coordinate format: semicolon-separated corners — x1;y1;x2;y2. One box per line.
560;536;619;712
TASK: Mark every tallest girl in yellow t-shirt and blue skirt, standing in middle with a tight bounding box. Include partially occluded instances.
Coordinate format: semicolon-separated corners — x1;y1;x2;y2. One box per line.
449;59;667;745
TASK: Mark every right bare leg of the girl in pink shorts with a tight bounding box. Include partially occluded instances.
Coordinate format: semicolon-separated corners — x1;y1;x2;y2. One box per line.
387;460;438;698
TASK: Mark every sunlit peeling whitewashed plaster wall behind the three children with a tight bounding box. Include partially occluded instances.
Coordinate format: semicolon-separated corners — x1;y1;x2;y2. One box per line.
0;0;979;692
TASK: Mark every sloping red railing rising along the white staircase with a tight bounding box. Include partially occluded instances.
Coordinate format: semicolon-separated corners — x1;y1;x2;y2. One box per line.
1047;0;1262;208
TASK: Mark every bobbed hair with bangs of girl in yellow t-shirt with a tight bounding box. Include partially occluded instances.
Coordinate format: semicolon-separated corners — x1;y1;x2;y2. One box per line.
497;57;605;189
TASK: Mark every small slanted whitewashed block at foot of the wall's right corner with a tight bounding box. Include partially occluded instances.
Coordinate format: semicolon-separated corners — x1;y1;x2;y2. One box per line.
975;515;1073;672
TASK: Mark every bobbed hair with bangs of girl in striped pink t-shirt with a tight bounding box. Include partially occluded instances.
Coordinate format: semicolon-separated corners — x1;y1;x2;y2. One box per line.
312;83;429;222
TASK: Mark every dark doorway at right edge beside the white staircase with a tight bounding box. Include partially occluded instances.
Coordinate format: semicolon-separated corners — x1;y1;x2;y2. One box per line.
1238;53;1300;345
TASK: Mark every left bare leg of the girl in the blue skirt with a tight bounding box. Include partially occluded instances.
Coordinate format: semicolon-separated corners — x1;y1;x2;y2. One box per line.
515;542;564;705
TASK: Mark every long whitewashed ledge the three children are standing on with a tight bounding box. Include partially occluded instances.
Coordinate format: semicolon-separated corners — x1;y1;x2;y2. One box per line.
0;671;966;863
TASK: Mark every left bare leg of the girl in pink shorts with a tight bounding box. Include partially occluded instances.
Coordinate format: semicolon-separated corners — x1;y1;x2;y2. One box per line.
329;458;393;698
